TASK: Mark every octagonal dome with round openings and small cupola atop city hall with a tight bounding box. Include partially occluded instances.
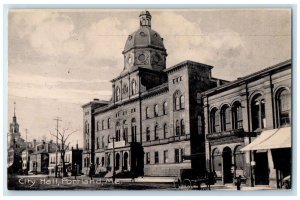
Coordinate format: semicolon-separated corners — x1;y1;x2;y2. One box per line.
121;11;167;75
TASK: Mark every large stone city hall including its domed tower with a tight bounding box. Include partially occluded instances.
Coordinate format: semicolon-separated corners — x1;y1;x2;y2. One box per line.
82;12;226;176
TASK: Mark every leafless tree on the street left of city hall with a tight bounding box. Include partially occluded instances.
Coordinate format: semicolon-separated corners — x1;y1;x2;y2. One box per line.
50;128;77;177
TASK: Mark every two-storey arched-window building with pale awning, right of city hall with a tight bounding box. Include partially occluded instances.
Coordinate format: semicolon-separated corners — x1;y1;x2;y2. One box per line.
201;60;292;187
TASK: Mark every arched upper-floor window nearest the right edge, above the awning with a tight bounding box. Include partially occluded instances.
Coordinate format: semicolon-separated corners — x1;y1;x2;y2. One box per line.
277;89;291;126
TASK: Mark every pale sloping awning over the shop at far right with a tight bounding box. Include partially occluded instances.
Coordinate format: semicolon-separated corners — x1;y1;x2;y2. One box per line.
241;127;291;151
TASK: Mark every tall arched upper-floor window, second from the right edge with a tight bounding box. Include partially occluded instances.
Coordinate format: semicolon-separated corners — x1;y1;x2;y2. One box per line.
251;94;266;130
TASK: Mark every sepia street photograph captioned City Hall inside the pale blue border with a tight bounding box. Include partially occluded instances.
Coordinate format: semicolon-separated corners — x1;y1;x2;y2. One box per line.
7;7;294;193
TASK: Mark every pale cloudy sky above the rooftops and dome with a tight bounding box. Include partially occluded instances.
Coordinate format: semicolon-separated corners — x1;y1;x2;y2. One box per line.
7;9;292;146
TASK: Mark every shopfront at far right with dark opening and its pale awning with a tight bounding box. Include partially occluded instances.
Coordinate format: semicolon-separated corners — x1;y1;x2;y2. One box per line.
241;127;292;188
